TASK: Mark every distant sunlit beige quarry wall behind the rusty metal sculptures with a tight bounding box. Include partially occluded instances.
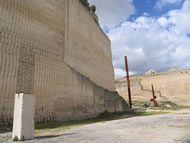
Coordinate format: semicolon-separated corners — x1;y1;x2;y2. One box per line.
116;70;190;106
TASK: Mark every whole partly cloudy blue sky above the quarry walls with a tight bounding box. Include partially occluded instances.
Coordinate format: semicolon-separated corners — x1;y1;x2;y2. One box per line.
89;0;190;78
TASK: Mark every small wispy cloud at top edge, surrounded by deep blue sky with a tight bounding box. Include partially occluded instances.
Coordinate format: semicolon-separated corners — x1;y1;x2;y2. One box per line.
155;0;182;10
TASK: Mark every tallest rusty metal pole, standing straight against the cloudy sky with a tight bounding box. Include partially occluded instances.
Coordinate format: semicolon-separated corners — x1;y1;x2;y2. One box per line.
125;56;132;108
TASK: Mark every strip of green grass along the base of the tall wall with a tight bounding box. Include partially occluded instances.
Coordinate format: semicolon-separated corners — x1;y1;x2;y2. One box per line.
35;111;166;134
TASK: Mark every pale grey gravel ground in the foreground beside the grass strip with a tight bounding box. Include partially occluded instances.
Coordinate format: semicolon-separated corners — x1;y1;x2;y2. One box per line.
0;113;190;143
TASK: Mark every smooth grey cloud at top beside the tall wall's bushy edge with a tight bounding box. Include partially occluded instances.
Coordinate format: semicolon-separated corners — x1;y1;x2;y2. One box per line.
89;0;135;27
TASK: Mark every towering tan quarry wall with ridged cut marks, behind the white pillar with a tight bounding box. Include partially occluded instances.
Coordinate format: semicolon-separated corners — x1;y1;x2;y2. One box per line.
0;0;127;122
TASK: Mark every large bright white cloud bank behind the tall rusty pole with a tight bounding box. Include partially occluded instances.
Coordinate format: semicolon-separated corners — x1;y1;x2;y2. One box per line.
108;0;190;78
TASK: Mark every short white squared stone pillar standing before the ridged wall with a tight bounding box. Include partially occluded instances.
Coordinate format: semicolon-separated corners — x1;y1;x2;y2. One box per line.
12;93;35;140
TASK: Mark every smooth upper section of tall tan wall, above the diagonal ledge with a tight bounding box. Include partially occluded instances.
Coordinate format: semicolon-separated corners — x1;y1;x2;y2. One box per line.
65;0;115;91
